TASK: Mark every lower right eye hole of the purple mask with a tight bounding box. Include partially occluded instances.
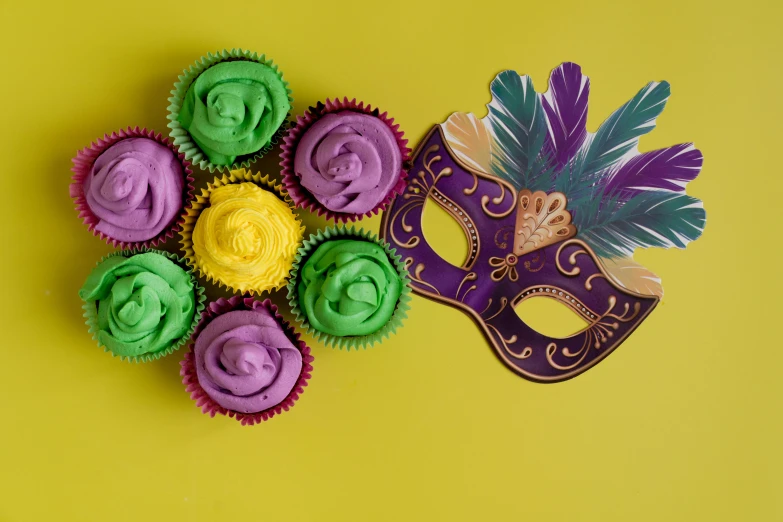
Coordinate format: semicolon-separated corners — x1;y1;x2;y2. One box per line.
514;296;589;339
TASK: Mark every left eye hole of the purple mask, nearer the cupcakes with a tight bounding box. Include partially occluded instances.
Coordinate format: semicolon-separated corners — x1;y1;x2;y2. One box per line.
421;198;468;266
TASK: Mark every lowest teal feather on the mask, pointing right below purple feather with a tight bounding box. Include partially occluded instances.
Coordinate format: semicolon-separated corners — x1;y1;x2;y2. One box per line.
575;191;705;257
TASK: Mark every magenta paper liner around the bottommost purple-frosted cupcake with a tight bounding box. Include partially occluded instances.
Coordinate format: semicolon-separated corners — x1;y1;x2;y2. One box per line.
179;296;314;426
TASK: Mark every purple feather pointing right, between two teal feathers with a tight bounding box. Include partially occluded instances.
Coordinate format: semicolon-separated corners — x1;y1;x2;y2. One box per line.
605;143;703;201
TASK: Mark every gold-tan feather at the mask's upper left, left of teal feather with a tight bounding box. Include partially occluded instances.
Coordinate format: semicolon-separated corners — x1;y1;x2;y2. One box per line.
442;112;492;174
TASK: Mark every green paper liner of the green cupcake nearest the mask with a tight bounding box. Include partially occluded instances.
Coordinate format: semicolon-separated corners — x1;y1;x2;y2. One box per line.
287;225;411;350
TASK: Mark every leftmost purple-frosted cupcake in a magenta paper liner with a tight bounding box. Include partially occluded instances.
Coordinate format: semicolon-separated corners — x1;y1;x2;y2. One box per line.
70;127;193;248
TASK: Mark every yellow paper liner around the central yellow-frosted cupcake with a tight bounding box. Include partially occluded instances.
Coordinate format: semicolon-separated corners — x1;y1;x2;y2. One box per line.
179;169;304;295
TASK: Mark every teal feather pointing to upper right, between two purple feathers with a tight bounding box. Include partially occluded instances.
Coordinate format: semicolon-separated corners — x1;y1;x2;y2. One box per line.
582;82;671;175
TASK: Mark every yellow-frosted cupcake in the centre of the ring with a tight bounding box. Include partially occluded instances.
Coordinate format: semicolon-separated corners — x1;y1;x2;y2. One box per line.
181;169;304;295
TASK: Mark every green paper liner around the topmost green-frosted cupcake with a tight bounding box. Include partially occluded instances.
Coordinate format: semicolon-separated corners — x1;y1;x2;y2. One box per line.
167;49;294;172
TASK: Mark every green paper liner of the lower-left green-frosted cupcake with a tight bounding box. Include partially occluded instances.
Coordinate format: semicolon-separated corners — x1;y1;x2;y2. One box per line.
82;248;207;363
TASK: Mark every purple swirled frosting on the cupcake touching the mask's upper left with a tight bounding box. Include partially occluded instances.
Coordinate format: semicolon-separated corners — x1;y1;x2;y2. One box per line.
294;111;402;214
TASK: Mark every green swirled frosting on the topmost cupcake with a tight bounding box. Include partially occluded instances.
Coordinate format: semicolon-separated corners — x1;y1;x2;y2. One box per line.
178;60;291;165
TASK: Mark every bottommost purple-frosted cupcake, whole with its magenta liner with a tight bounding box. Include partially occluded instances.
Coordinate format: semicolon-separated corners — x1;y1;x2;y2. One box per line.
180;296;313;425
